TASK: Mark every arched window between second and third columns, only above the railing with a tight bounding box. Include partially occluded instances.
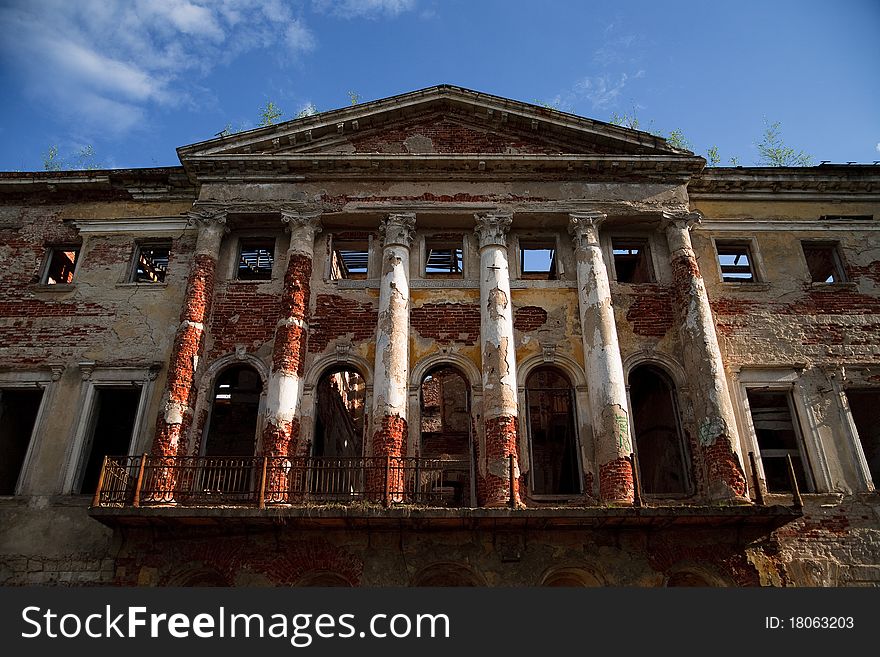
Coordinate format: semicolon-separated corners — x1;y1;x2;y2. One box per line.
312;367;367;458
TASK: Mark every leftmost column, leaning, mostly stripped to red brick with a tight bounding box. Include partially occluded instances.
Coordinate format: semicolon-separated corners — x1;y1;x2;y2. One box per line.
152;209;226;501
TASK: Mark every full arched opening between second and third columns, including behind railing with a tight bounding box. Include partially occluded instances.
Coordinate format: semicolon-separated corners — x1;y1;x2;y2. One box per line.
309;369;367;499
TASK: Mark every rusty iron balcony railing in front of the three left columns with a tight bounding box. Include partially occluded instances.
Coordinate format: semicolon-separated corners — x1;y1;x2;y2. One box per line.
93;454;474;508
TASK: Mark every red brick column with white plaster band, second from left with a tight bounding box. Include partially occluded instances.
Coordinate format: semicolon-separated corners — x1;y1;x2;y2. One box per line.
262;210;321;502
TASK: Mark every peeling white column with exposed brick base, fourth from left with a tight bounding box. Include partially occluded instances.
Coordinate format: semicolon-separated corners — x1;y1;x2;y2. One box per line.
474;213;521;507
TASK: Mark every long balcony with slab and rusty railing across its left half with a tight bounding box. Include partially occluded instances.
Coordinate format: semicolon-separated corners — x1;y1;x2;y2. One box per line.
89;455;802;531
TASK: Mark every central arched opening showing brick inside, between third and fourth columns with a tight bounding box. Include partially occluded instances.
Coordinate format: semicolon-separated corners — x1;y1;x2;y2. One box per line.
420;367;476;506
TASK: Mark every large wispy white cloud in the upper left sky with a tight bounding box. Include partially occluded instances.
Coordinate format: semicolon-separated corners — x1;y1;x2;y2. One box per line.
0;0;316;132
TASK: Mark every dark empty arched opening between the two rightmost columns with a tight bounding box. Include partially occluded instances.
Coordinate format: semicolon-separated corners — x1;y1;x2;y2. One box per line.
629;365;690;495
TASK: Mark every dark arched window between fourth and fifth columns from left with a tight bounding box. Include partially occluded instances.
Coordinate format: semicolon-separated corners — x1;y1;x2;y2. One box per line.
526;367;581;495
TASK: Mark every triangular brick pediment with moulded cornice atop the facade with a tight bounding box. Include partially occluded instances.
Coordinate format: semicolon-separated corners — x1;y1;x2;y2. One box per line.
178;85;691;166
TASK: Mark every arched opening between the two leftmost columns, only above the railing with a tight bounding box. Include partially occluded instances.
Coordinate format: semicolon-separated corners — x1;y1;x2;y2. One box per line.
204;365;263;456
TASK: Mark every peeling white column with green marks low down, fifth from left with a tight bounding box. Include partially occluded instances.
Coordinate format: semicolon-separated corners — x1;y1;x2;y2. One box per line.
568;212;633;504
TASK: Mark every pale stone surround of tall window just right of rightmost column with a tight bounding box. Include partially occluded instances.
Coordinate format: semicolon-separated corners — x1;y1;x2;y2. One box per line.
730;366;832;494
